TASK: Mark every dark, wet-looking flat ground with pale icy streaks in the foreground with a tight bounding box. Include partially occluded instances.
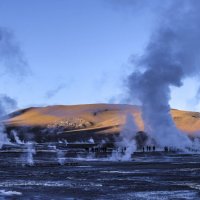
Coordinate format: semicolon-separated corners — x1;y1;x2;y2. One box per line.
0;145;200;200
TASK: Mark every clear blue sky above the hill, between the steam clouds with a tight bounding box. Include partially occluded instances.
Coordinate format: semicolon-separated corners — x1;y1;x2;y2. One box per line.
0;0;200;111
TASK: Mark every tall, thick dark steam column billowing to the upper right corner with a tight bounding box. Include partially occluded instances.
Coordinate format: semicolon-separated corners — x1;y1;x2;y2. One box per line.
127;0;200;147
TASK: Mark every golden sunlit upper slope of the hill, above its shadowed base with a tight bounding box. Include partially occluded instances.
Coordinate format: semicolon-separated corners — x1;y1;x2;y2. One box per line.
5;104;200;134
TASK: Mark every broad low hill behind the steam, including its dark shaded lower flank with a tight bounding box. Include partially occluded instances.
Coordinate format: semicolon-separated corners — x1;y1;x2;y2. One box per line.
4;104;200;140
